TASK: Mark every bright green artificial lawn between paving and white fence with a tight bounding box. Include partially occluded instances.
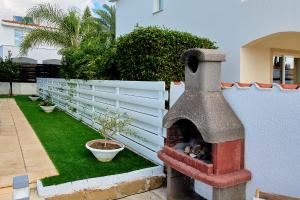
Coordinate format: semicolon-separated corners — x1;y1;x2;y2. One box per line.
15;96;155;186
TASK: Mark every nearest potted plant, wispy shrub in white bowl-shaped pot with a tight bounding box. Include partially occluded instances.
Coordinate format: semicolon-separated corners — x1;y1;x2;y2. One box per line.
85;109;134;162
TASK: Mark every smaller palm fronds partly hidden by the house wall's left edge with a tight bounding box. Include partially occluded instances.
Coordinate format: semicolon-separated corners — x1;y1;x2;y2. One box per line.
95;4;116;39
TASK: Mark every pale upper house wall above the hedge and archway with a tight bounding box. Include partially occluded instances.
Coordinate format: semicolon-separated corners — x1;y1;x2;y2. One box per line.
117;0;300;81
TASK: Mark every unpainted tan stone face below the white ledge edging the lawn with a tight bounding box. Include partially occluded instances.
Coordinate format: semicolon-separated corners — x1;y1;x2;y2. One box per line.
47;176;165;200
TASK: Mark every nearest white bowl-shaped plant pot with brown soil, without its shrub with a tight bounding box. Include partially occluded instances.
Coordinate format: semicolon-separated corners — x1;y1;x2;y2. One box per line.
85;139;125;162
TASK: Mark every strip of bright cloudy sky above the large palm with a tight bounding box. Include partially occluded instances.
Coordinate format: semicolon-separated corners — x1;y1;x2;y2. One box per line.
0;0;112;19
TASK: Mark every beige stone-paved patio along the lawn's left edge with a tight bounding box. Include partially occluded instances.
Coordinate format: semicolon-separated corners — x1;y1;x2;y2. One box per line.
0;99;58;200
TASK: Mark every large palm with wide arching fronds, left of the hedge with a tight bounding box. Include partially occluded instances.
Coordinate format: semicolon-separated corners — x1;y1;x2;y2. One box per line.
20;3;100;54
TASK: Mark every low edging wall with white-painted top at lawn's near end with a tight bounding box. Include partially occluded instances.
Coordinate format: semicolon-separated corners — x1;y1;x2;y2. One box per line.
37;166;165;199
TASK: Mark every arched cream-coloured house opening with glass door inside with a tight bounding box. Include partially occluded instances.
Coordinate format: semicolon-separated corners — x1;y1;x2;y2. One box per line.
240;32;300;84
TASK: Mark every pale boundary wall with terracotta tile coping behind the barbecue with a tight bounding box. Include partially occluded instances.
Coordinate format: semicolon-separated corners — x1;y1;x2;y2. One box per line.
170;84;300;200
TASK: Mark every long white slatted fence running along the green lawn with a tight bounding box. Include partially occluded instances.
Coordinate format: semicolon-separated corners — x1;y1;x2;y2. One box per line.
37;78;168;165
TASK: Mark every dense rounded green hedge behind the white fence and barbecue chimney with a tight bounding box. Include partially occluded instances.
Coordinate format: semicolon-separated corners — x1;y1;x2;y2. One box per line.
115;27;216;84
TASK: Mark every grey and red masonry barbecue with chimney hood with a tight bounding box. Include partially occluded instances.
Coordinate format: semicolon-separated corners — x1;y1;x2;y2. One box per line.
158;49;251;200
